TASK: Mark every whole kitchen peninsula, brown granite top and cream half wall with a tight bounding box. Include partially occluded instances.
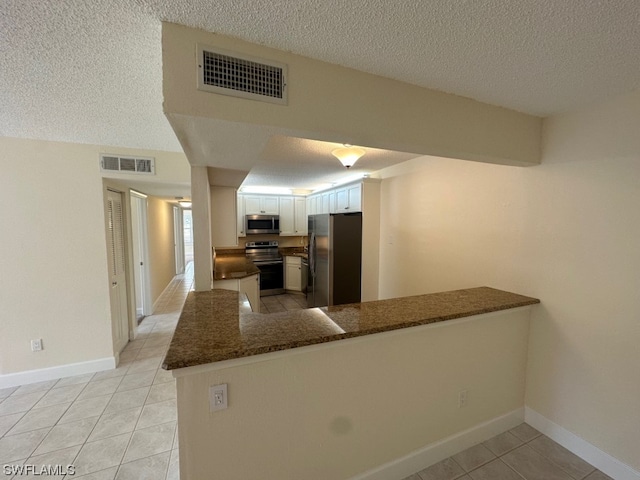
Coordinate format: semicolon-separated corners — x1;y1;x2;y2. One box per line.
163;287;539;480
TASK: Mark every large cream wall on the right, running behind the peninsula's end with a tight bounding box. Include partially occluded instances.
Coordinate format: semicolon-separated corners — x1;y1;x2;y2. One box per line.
380;88;640;470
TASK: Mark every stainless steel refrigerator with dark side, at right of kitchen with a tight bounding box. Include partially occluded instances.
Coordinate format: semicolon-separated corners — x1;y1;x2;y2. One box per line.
307;212;362;308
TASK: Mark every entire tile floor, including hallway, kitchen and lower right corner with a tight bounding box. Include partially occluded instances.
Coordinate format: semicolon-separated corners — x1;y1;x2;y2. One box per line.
0;270;611;480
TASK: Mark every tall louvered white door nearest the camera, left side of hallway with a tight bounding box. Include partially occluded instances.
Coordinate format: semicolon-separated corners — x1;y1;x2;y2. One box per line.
107;190;129;353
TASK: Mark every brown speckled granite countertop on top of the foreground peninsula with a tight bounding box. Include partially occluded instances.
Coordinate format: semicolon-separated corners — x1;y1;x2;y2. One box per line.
162;287;540;370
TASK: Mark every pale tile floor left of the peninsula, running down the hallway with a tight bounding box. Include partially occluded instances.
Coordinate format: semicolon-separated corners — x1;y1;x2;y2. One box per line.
0;264;193;480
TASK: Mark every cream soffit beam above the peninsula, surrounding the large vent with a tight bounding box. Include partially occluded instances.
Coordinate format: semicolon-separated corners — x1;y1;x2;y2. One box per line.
162;23;542;171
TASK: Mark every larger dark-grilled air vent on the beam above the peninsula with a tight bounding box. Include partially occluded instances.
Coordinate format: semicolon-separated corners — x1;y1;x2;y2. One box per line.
198;45;287;105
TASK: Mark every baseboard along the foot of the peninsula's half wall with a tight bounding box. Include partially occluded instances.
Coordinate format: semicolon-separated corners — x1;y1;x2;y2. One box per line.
351;408;524;480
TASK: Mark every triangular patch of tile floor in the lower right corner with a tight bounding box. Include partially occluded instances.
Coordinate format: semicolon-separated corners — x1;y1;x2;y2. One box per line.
404;423;611;480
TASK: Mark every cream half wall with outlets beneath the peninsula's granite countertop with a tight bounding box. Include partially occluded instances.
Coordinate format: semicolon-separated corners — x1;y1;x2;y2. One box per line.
177;306;538;480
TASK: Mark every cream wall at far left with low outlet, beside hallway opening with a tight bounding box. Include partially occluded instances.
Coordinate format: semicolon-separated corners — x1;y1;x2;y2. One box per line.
0;138;189;381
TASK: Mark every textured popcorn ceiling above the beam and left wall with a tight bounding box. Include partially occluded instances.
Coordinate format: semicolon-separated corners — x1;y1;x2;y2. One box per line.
0;0;640;189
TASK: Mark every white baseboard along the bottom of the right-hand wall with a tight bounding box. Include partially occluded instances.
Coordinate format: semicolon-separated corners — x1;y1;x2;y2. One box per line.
524;407;640;480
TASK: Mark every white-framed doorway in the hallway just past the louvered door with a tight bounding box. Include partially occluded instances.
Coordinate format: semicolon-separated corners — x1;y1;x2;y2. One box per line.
129;190;153;323
